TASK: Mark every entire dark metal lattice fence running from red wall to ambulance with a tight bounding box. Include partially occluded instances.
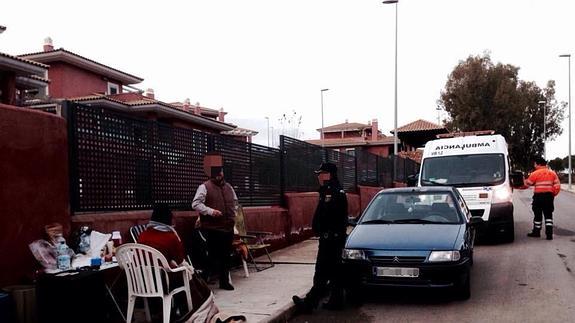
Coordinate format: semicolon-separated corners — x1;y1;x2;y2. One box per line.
63;102;418;212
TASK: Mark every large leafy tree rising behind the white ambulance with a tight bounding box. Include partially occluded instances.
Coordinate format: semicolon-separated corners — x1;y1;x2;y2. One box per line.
439;53;566;170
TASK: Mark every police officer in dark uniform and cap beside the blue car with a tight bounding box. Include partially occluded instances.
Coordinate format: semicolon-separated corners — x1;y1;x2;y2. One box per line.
292;163;348;313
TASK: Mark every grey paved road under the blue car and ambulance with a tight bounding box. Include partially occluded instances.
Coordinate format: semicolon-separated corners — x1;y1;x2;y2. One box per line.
292;190;575;322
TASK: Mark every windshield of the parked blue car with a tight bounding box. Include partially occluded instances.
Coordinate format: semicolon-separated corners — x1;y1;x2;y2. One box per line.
359;192;463;225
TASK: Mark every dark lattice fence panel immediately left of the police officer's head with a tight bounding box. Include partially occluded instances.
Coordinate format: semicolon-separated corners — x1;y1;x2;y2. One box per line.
280;136;325;192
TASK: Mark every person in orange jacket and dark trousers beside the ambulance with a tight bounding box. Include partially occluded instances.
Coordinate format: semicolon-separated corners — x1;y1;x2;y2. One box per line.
525;157;561;240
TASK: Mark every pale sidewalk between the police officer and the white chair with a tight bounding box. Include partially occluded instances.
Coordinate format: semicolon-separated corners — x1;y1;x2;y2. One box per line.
210;239;318;323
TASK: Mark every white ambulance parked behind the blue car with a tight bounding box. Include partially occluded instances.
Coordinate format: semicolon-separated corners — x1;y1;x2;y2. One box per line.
418;131;514;242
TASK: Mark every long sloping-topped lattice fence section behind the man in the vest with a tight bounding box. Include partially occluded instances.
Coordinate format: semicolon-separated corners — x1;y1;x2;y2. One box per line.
66;103;281;212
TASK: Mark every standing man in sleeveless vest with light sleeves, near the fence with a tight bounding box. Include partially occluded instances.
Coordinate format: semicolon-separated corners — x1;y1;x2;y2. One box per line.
192;152;238;290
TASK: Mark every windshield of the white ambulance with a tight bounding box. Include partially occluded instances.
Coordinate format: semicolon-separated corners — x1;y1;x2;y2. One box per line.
421;154;505;186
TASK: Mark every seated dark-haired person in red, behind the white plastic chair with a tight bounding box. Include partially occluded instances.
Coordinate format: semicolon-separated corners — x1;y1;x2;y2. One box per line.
138;204;186;268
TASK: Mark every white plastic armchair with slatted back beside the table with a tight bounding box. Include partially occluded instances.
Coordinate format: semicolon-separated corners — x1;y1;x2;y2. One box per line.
116;243;192;323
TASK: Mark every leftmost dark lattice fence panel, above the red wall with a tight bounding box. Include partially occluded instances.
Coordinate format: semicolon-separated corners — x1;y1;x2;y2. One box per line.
70;105;158;211
